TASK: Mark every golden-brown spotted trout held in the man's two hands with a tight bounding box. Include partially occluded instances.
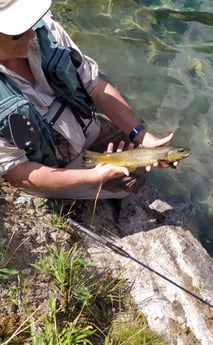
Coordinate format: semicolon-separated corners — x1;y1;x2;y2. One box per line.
83;146;190;170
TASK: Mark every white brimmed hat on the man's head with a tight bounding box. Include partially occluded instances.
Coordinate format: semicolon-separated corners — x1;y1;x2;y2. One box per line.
0;0;52;35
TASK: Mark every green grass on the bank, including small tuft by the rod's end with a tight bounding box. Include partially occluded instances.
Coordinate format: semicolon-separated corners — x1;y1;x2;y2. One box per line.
0;196;167;345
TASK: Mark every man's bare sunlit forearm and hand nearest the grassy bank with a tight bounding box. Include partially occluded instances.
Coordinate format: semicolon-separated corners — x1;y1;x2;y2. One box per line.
3;161;128;191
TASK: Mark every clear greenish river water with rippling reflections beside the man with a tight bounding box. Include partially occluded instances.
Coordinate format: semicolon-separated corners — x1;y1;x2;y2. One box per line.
52;0;213;255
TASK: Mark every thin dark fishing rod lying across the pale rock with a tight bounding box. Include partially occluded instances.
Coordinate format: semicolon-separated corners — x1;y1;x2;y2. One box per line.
68;218;213;308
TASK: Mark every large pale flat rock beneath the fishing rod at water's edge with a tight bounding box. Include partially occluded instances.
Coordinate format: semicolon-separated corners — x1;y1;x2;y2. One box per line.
80;186;213;345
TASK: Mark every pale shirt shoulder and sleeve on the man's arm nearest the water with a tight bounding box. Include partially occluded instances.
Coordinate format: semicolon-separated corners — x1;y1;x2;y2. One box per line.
43;12;99;93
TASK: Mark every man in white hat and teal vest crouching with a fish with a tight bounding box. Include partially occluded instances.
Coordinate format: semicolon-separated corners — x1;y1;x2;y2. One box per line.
0;0;176;199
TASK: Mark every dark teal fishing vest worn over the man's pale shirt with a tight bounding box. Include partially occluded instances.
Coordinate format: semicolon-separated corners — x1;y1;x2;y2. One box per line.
0;20;94;167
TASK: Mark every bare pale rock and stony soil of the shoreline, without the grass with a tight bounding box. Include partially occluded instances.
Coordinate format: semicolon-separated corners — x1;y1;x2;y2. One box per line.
0;184;213;345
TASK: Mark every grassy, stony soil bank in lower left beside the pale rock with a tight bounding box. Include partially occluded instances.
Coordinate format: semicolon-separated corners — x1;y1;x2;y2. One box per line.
0;186;166;345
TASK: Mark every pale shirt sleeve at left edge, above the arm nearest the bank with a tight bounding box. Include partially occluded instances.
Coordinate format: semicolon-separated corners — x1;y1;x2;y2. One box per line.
0;138;28;181
